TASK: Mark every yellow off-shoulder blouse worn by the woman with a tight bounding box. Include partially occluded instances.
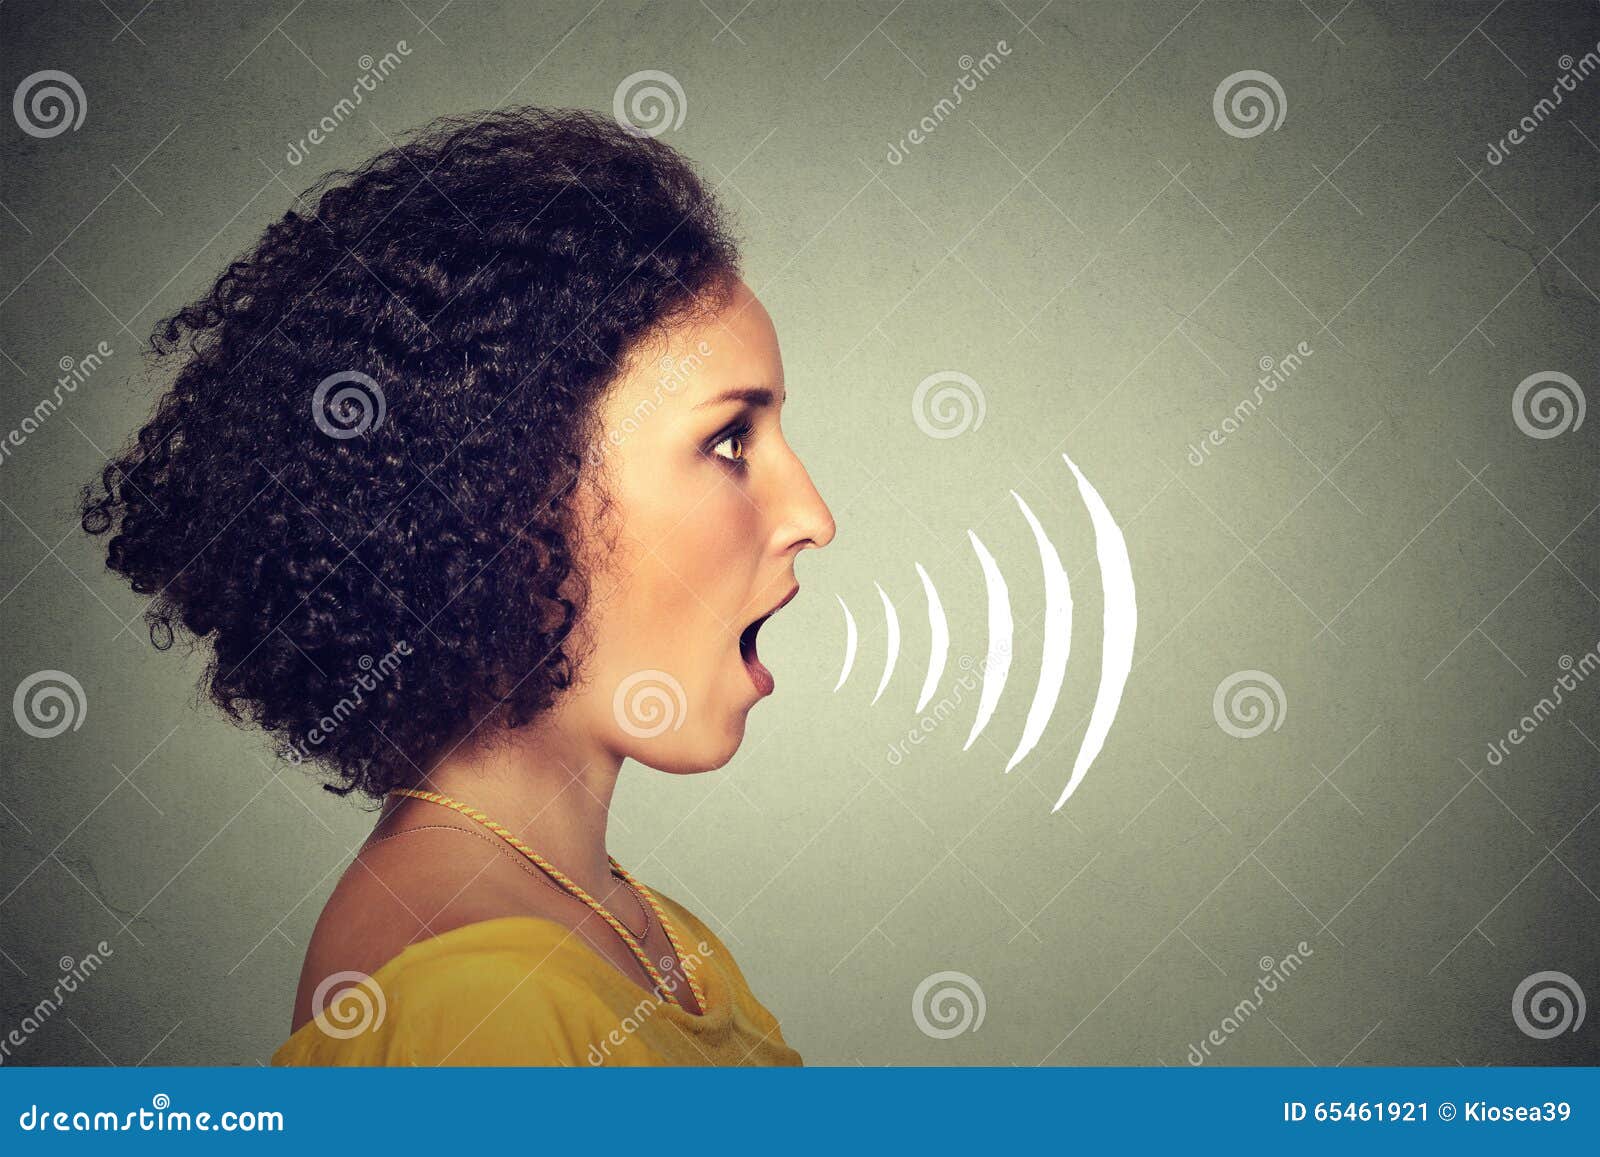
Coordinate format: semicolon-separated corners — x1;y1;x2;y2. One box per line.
272;890;802;1066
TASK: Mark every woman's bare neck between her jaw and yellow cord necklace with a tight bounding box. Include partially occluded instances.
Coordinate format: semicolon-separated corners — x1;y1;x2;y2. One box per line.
384;725;622;904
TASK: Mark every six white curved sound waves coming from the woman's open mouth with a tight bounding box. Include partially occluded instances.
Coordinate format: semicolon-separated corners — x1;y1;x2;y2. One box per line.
834;454;1139;813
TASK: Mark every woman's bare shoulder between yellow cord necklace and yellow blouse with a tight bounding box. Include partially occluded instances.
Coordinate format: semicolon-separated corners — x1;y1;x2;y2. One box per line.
291;827;573;1031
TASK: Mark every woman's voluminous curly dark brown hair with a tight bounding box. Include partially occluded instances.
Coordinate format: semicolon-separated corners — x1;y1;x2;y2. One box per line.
78;107;739;799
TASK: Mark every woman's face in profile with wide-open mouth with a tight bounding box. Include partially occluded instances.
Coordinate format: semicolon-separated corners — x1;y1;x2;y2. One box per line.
570;282;834;771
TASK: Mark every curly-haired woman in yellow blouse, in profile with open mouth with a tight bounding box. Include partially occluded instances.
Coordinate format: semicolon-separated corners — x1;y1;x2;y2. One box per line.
82;107;834;1064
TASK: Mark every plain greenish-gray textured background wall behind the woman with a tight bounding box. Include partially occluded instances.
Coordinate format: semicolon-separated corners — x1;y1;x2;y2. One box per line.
0;0;1600;1064
